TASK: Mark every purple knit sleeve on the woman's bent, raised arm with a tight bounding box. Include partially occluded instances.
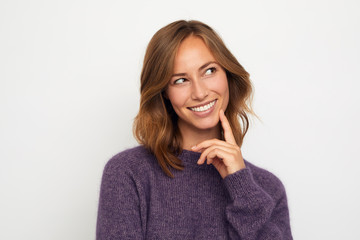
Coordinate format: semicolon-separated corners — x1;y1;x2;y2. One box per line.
224;168;292;240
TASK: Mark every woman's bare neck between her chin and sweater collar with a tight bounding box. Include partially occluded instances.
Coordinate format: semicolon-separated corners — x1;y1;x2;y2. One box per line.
178;122;221;151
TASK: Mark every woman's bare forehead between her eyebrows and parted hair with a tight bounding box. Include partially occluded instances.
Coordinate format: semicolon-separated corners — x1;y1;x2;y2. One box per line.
174;36;215;72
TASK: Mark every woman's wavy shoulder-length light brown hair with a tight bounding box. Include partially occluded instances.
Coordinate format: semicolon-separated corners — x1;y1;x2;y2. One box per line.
133;20;253;177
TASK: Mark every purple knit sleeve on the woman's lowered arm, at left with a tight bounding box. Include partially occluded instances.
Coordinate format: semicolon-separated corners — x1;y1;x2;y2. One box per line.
96;159;144;240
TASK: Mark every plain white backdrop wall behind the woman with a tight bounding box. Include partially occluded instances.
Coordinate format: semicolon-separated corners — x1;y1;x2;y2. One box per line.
0;0;360;240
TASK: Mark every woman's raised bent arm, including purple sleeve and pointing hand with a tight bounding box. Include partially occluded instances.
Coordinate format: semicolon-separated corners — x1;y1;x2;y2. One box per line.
192;110;292;240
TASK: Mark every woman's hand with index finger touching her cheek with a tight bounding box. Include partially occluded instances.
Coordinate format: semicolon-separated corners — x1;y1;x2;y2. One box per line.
192;110;245;178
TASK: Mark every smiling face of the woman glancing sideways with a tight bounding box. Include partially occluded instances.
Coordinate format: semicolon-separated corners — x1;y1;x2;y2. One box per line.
165;36;229;132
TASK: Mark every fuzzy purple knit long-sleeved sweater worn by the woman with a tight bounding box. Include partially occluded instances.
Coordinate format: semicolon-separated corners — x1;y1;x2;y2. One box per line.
96;146;292;240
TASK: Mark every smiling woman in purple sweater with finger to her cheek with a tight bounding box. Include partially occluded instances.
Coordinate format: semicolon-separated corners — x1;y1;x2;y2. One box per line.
97;21;292;239
